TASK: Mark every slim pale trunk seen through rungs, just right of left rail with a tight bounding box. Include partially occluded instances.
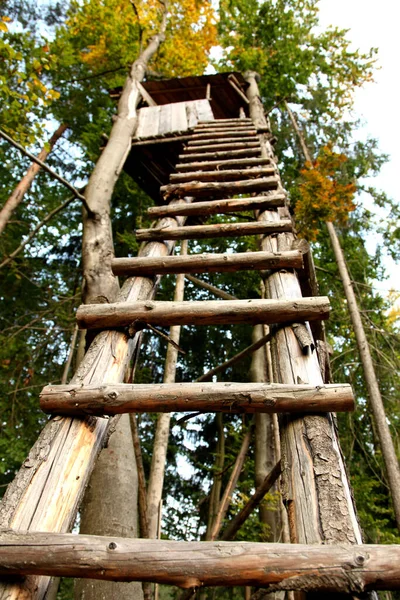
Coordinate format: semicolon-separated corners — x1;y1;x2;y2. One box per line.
147;240;188;539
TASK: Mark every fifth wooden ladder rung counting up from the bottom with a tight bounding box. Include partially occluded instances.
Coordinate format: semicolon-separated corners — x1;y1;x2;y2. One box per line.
136;219;292;242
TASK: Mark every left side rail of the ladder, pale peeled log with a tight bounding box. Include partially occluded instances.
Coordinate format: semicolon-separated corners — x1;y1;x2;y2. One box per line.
0;199;189;600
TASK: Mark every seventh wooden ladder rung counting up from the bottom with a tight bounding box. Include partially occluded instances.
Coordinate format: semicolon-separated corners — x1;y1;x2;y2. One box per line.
160;177;278;200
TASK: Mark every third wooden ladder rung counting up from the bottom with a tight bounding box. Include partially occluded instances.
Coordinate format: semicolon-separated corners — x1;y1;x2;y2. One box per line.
76;296;329;329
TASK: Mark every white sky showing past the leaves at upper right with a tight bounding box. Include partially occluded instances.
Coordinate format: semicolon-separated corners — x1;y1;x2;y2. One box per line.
319;0;400;289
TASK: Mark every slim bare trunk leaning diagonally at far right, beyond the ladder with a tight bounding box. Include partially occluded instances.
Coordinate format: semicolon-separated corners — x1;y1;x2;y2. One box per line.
285;103;400;530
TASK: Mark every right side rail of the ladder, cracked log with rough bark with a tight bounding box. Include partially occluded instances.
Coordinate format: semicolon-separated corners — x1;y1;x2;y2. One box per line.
247;72;362;544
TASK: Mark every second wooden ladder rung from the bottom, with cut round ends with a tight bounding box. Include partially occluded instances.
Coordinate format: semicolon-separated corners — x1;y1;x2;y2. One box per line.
40;382;354;416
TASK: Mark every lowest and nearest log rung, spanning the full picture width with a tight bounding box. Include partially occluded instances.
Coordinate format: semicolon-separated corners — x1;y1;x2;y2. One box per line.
0;532;400;595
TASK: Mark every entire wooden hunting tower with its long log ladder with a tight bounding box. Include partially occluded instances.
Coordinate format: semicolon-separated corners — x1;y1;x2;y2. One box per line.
0;73;400;599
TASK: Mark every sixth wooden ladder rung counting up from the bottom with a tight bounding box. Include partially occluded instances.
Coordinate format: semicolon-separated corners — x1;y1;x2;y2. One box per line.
147;193;288;219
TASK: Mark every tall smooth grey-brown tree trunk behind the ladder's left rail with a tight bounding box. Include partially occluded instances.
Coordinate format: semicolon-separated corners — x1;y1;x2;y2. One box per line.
75;5;167;600
